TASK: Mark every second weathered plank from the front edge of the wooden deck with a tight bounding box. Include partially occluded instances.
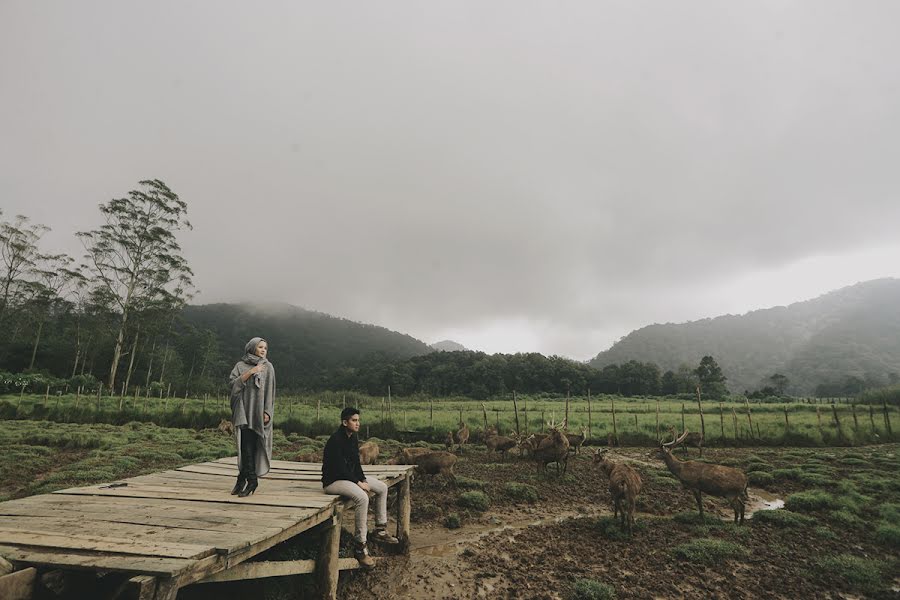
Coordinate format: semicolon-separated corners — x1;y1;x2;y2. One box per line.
0;527;213;558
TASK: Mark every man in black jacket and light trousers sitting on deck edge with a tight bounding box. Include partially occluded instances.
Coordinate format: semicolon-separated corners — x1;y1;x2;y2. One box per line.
322;407;398;569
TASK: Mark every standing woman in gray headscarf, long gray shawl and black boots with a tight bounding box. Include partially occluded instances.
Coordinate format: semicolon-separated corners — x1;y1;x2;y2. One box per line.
230;337;275;498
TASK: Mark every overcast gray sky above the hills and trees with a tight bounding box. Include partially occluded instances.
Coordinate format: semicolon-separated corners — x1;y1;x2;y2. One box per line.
0;0;900;359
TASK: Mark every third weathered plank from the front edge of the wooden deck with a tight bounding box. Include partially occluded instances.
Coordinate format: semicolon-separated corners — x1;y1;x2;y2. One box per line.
0;516;256;553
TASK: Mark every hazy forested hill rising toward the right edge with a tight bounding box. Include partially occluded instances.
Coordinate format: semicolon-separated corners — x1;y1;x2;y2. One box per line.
588;279;900;394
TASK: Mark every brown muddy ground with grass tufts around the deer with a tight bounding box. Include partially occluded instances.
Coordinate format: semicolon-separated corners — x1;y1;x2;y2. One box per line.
339;445;900;600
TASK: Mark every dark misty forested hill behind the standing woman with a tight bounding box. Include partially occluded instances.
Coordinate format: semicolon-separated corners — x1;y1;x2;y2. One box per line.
183;304;434;389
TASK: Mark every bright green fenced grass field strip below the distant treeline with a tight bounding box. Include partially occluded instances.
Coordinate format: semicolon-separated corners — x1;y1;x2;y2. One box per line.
0;393;900;446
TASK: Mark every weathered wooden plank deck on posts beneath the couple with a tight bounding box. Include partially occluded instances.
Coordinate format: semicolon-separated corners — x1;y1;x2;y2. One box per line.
0;457;413;600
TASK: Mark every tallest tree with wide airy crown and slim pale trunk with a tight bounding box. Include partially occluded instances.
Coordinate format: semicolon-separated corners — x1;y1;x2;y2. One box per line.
77;179;193;389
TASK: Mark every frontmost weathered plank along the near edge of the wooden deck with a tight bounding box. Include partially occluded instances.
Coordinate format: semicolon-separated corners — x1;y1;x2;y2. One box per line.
0;545;199;576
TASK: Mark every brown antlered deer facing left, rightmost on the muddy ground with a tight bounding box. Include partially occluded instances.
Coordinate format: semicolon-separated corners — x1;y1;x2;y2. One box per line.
650;431;749;523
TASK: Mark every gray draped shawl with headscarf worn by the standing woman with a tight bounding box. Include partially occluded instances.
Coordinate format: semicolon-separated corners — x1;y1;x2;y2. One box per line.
229;338;275;476
